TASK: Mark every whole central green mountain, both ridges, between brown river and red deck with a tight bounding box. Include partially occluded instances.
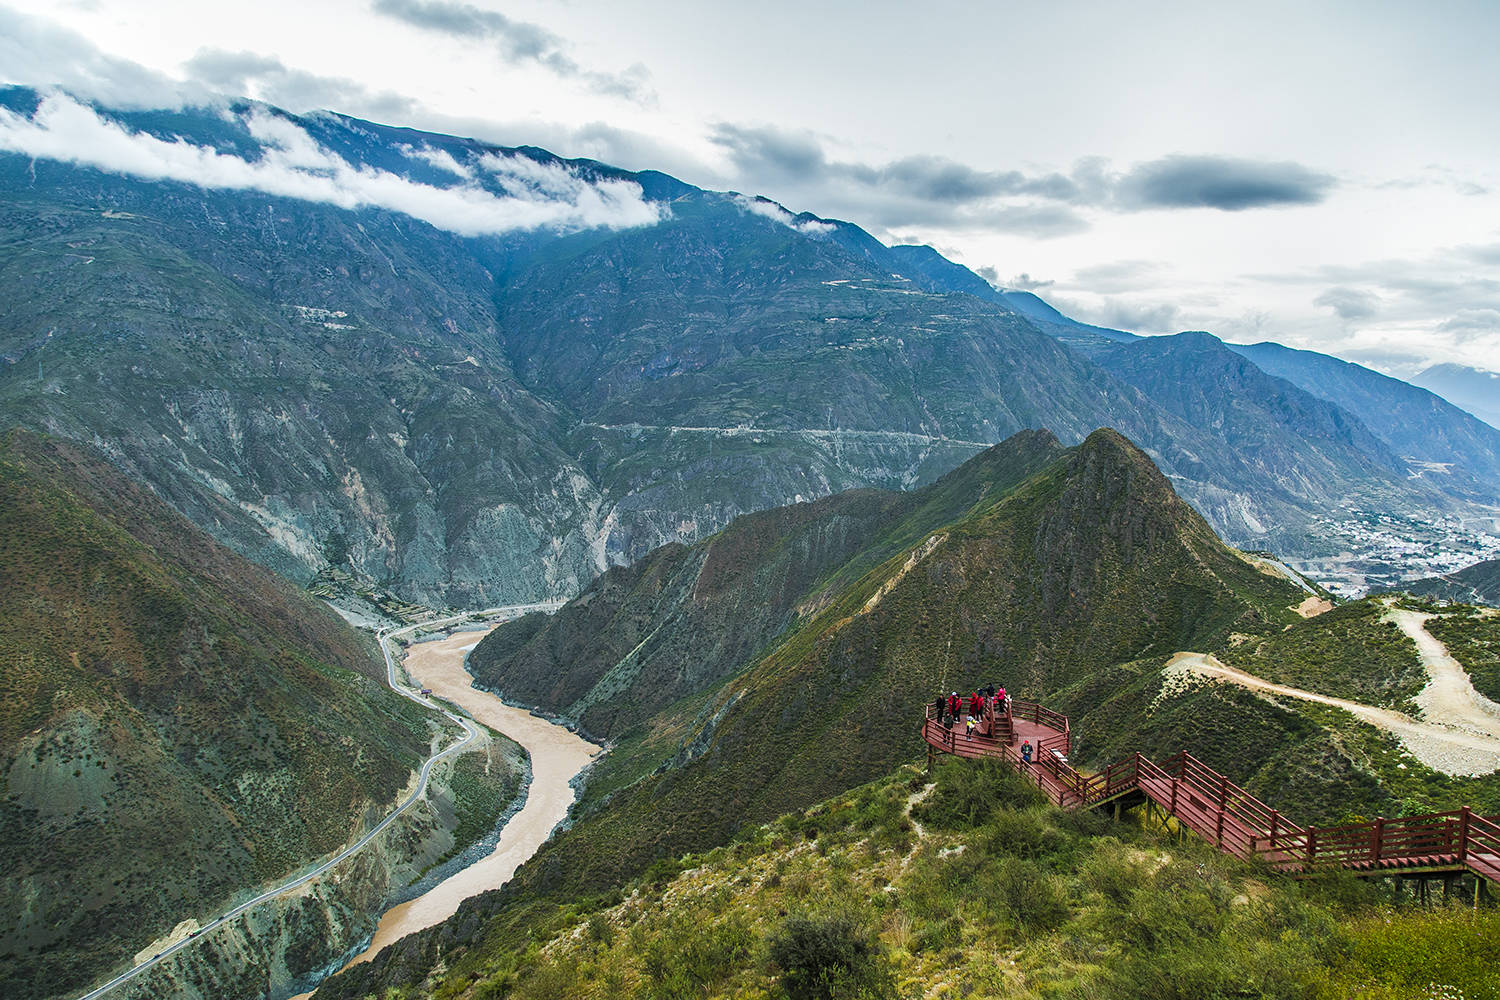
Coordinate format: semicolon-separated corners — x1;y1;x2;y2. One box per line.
320;430;1500;997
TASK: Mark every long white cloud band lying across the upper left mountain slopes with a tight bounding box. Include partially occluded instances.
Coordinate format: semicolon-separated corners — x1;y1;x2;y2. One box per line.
0;94;666;235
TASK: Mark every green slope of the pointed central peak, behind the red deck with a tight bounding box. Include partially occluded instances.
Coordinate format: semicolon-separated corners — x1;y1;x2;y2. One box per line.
465;430;1301;885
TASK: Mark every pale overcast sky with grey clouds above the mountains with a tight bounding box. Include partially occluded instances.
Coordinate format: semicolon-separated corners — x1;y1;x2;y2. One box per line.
0;0;1500;376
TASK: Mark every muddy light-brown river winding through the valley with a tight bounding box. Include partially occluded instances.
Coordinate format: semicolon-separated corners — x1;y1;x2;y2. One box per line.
294;631;600;1000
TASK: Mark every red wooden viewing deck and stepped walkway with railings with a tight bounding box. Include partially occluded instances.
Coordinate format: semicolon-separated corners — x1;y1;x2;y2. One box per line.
923;702;1500;885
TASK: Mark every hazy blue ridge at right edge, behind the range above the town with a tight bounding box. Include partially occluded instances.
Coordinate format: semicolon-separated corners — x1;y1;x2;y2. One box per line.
1226;343;1500;502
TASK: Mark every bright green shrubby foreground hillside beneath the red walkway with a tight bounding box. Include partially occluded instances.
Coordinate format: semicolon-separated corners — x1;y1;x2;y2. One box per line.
366;762;1500;1000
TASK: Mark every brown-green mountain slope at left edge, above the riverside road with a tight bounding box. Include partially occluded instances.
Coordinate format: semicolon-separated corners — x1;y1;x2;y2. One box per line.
0;432;431;997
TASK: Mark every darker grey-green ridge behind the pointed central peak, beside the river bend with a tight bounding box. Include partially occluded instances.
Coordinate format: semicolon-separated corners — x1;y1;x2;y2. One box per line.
468;432;1062;738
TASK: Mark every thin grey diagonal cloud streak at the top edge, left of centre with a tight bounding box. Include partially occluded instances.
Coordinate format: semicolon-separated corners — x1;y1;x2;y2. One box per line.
371;0;656;103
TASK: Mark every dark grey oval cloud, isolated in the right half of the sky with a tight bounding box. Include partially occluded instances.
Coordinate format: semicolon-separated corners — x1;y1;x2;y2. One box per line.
1116;154;1335;211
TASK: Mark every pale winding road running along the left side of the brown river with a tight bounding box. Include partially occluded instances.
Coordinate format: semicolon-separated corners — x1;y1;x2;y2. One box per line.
78;601;561;1000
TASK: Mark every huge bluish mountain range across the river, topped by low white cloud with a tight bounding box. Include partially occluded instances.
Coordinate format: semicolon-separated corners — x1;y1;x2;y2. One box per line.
0;88;1500;606
